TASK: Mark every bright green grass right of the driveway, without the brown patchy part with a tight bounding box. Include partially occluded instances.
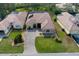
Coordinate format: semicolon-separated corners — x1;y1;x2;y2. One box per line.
35;37;65;53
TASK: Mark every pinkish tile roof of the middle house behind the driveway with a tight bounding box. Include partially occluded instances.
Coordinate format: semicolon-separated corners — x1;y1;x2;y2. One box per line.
26;12;54;29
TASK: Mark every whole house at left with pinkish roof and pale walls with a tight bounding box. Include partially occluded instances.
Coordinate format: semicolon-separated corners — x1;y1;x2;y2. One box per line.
0;12;27;37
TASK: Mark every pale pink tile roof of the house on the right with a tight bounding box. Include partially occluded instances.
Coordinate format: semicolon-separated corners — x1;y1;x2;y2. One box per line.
57;12;78;31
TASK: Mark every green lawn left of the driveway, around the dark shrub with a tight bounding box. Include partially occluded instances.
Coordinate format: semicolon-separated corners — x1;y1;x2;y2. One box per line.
0;31;24;53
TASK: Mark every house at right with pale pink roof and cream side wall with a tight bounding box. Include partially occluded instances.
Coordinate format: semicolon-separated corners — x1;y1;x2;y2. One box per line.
57;12;79;34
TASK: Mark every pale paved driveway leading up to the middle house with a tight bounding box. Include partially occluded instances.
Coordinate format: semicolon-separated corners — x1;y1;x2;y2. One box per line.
23;31;39;55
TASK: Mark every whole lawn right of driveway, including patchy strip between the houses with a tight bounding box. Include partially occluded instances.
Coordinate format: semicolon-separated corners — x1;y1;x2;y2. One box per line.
35;16;79;53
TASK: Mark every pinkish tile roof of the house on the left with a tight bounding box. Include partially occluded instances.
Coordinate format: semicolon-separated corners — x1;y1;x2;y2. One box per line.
0;12;27;30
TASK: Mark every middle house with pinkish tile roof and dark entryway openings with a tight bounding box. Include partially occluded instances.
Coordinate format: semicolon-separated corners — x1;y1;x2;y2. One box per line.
26;12;55;33
